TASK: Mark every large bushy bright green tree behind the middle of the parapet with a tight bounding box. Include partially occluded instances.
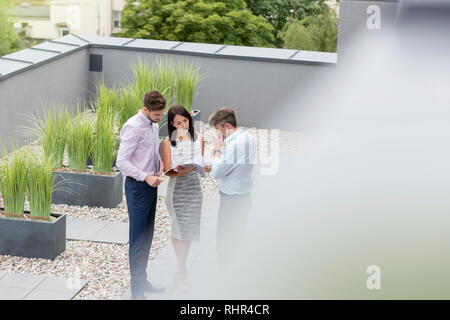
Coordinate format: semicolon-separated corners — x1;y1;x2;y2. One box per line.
120;0;275;46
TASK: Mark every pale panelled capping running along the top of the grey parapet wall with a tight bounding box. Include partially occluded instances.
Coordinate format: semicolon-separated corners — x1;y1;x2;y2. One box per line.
0;34;337;81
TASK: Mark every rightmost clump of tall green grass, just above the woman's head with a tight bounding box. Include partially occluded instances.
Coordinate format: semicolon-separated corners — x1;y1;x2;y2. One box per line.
175;62;203;111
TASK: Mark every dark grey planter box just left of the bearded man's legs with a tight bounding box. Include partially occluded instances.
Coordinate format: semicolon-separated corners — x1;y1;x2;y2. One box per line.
52;171;123;208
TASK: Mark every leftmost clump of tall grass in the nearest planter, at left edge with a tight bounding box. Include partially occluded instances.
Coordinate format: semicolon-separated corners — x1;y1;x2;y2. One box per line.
0;149;28;218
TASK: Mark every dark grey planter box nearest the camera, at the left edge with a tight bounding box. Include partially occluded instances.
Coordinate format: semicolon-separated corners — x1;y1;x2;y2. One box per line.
0;211;66;260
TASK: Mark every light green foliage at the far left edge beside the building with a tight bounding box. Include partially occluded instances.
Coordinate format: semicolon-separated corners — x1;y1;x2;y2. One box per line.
0;0;22;56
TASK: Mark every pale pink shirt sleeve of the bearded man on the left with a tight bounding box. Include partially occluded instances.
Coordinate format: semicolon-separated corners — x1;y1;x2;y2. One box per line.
116;124;147;181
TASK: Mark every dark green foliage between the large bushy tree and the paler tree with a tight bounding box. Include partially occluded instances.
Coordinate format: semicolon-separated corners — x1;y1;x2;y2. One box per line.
245;0;328;46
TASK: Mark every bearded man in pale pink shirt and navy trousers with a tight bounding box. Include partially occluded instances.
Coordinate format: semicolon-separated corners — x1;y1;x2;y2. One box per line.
116;91;166;300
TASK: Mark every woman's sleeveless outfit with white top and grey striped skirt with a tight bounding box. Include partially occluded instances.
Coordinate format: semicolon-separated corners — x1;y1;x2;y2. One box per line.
166;135;203;241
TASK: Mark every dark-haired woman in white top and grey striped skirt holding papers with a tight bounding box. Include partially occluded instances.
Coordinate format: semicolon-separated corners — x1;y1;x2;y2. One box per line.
161;105;210;290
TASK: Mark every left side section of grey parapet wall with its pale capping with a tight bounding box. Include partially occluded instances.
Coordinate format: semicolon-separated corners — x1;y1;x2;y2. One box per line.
0;40;89;149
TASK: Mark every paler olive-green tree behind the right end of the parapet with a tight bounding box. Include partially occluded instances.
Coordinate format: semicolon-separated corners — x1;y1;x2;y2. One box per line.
280;9;338;52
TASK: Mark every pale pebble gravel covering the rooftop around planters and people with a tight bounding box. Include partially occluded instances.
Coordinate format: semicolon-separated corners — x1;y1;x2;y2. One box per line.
0;123;307;300
